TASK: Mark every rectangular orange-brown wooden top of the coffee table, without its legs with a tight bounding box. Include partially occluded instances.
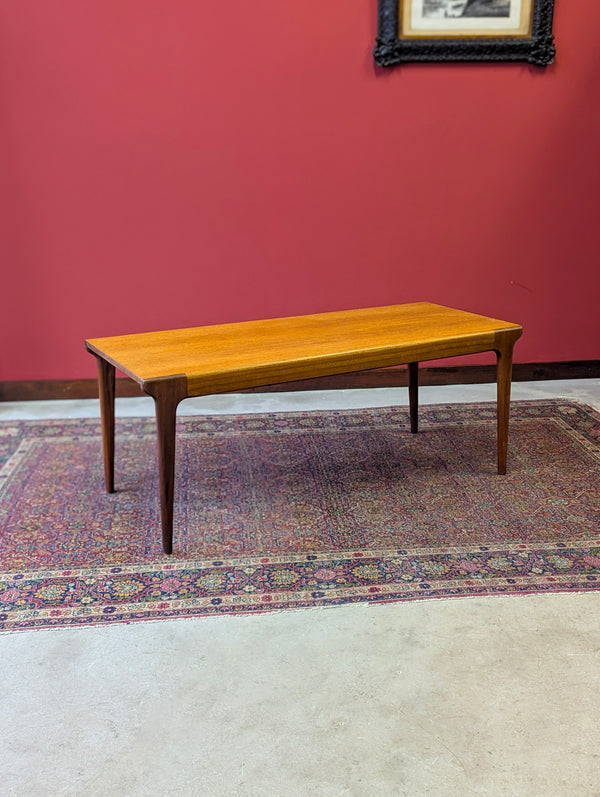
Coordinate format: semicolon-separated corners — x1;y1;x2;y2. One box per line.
86;302;521;396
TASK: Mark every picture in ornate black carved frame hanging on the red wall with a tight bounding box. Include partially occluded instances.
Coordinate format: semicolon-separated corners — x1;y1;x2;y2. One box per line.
373;0;556;66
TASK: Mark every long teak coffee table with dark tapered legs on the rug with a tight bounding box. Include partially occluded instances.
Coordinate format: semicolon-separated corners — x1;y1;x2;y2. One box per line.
85;302;523;554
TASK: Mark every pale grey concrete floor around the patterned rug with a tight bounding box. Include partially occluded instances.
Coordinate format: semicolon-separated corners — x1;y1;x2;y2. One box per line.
0;380;600;797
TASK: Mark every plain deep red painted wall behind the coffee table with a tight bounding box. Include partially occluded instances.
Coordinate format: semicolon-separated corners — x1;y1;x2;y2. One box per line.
0;0;600;380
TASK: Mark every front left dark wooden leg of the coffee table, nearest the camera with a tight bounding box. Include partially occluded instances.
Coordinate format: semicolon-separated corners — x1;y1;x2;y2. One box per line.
143;376;187;554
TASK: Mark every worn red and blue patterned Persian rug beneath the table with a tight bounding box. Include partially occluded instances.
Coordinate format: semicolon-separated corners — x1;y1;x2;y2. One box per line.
0;400;600;631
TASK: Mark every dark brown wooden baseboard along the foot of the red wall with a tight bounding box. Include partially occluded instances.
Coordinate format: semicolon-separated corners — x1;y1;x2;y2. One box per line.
0;360;600;401
